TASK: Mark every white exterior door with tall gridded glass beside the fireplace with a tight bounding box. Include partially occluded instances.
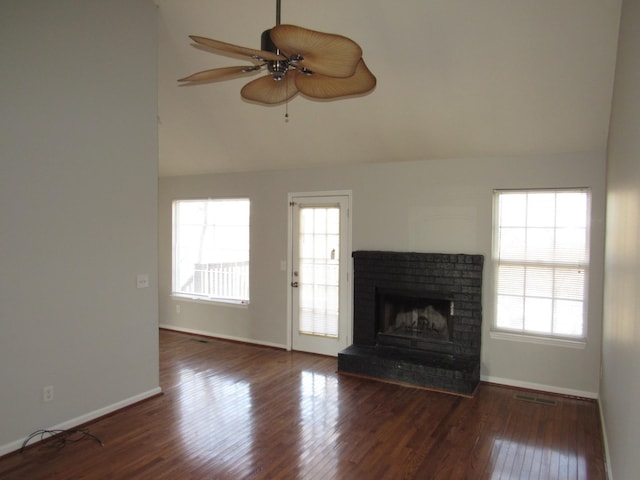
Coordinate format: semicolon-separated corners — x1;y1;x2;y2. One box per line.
289;194;351;356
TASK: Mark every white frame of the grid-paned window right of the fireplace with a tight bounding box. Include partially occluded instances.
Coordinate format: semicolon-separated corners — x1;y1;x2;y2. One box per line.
490;187;592;348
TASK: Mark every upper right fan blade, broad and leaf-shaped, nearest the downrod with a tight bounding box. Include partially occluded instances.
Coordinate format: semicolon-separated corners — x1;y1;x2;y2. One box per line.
271;25;362;78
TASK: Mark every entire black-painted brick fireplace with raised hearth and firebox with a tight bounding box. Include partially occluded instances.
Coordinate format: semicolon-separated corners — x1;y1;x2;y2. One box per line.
338;251;484;395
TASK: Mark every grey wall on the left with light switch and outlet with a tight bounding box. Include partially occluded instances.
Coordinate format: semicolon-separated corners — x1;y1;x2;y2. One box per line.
0;0;159;454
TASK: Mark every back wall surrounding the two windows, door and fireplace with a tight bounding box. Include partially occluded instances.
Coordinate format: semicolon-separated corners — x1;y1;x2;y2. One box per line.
159;152;605;396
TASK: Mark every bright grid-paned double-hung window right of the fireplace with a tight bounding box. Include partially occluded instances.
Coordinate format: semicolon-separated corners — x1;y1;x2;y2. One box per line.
494;189;590;339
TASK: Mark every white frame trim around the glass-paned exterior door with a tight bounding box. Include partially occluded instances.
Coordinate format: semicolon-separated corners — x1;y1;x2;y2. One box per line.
286;190;353;351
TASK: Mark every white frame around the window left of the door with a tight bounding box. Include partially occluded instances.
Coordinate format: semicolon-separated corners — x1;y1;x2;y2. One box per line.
171;197;251;305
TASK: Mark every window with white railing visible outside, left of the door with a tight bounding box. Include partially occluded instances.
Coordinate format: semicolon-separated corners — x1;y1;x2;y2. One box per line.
173;198;249;303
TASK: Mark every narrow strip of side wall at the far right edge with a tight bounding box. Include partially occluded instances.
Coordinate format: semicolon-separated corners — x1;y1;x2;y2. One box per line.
601;0;640;480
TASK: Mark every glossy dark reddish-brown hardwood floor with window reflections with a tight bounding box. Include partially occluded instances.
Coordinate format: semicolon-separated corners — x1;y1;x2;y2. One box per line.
0;331;606;480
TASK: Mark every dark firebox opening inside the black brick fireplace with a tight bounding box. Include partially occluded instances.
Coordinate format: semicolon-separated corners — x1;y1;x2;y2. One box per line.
375;289;455;353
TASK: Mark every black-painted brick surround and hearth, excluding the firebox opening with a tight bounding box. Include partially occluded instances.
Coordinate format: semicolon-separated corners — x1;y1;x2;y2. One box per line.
350;251;484;393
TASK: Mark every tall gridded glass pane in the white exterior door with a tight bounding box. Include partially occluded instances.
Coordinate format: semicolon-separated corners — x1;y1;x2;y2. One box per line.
299;207;340;337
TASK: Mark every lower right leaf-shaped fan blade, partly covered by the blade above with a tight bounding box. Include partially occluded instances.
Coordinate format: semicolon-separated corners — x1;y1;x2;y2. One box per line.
296;59;376;100
